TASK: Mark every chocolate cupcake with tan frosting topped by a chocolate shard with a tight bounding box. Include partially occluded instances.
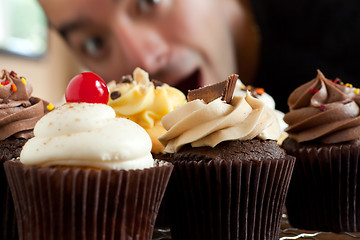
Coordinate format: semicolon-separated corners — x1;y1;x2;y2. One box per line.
159;75;295;240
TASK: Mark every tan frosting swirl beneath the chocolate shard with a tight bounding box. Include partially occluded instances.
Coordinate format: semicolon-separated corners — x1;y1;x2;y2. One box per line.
159;93;281;153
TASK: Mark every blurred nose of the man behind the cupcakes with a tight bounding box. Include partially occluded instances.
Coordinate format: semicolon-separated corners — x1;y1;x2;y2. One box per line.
114;19;169;74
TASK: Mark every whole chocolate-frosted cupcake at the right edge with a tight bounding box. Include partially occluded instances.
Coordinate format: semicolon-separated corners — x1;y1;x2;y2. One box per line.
282;71;360;232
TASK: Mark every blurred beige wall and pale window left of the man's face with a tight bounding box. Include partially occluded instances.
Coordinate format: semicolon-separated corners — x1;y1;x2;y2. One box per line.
0;0;82;104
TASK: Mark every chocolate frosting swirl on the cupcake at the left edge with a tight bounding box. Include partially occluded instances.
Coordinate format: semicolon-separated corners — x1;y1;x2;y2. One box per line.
0;70;47;141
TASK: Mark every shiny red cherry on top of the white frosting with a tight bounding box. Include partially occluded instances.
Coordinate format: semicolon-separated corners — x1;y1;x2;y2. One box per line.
65;72;109;104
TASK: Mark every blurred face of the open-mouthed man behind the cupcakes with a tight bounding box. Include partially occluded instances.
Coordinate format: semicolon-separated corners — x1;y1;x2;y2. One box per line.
39;0;236;93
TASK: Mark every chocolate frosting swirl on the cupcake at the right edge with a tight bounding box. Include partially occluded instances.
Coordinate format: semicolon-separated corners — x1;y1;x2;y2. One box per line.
284;70;360;144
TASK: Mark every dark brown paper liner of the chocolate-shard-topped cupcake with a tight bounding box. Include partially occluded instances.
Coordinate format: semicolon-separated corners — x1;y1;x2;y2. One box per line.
167;156;295;240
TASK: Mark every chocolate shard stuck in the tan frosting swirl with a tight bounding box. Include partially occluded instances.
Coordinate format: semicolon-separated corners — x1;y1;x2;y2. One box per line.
187;74;239;103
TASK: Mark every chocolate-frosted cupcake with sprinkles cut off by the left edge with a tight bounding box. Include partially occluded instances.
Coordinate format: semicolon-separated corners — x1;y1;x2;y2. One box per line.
0;70;53;239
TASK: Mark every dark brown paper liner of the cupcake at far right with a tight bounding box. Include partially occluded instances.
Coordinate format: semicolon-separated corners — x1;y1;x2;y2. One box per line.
286;145;360;232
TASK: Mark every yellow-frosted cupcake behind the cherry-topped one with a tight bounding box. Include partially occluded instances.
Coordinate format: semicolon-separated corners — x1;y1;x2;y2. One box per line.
108;68;186;157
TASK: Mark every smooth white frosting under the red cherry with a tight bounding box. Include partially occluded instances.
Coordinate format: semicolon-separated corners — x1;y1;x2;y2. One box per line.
20;103;154;170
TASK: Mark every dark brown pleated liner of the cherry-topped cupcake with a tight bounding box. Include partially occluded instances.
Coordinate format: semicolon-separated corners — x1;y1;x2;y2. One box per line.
5;161;172;240
